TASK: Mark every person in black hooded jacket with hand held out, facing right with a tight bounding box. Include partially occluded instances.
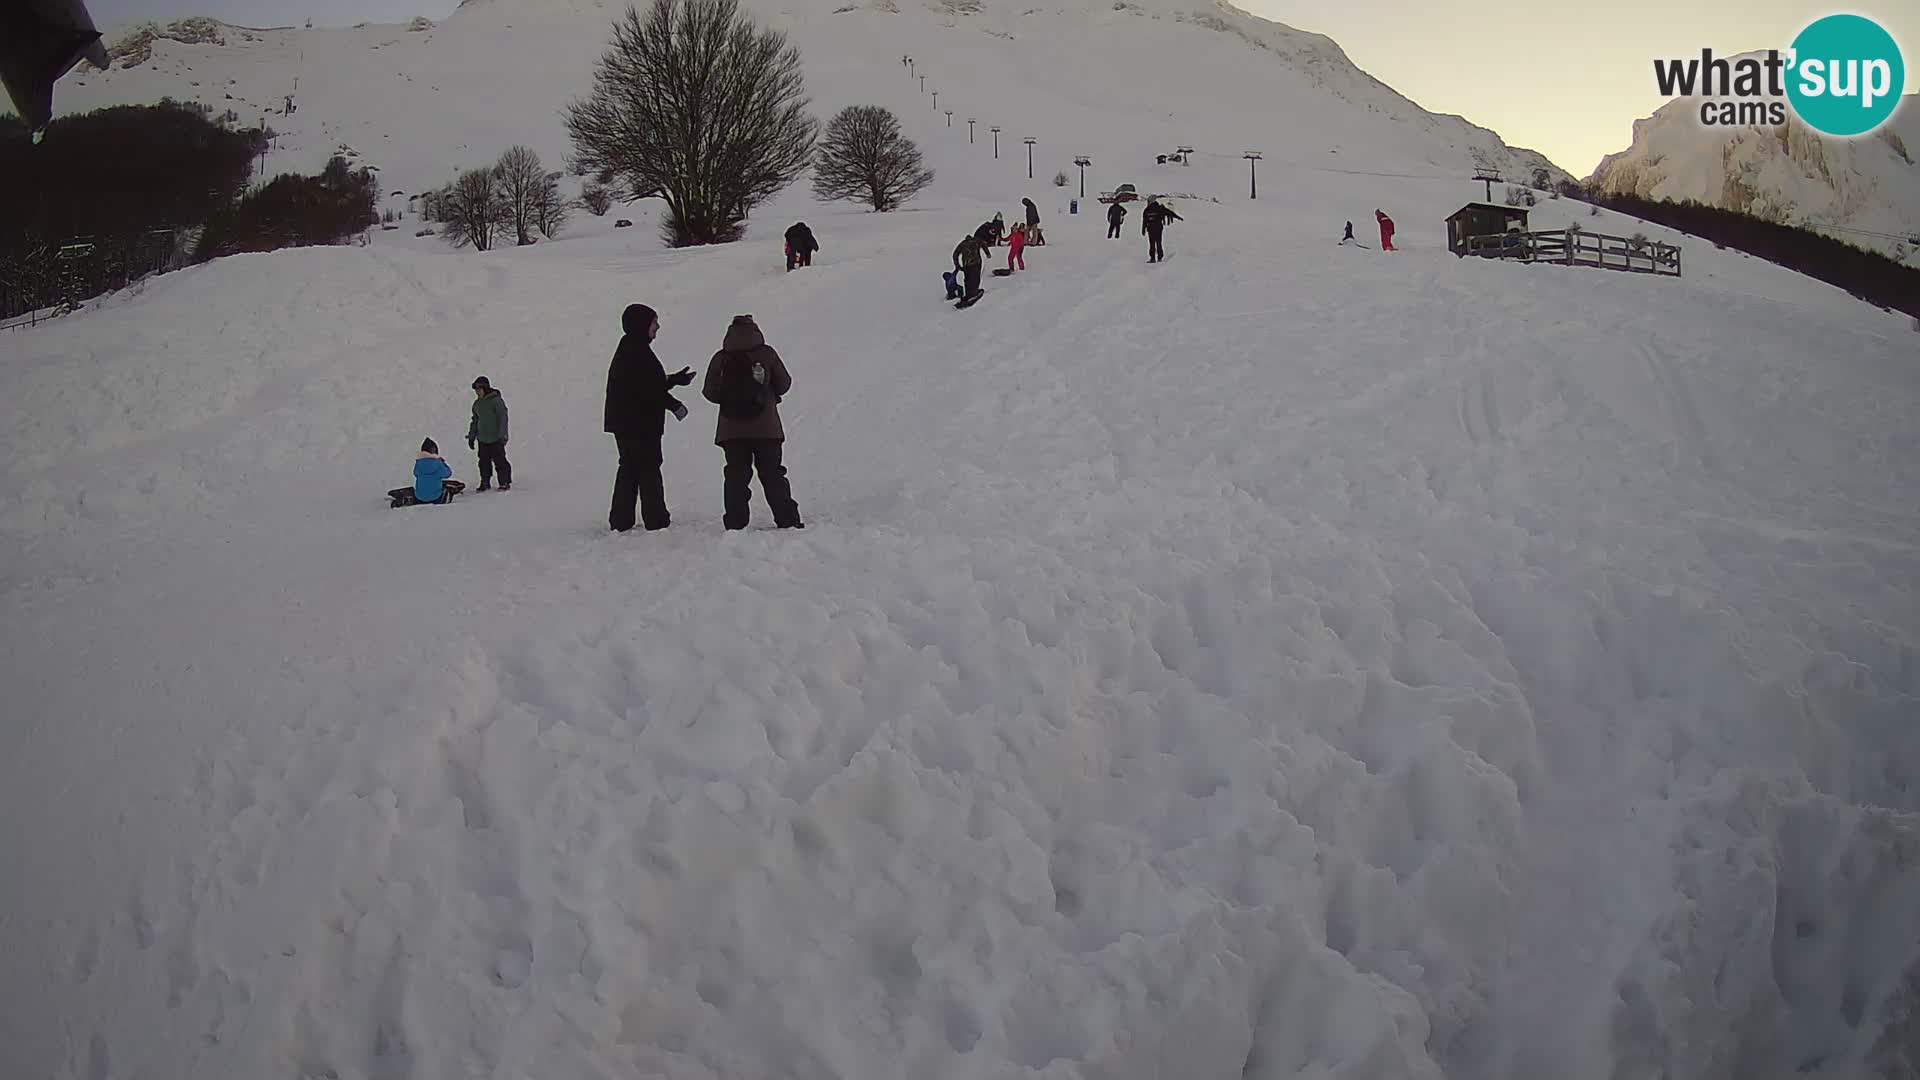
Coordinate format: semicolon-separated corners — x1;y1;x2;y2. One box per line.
603;304;693;532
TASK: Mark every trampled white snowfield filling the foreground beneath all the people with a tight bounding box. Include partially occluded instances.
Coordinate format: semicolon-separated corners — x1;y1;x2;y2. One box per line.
0;2;1920;1080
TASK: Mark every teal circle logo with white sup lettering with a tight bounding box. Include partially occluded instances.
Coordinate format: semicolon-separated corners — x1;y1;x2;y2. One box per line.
1788;15;1907;135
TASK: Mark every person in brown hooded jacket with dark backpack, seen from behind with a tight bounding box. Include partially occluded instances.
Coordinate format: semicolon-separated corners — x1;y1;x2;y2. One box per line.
701;315;806;528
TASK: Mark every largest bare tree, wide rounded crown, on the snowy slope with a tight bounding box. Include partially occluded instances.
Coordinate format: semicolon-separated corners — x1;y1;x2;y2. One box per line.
566;0;818;248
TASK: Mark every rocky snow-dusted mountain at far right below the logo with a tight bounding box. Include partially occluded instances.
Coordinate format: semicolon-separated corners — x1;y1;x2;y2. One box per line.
1592;83;1920;252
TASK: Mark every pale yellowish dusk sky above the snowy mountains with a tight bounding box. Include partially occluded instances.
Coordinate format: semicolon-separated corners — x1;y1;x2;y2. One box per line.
88;0;1920;177
